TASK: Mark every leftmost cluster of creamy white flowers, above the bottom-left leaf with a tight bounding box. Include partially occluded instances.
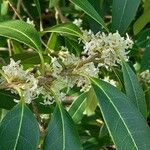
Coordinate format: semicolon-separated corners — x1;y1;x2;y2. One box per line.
1;59;39;103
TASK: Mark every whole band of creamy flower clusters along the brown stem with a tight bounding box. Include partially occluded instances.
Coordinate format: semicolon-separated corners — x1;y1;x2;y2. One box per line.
0;20;133;105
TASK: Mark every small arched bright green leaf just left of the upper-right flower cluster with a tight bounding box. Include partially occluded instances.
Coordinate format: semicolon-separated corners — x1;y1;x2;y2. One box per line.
43;23;82;37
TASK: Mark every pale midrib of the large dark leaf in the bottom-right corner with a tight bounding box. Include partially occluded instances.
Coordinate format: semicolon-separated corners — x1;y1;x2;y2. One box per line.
91;79;138;150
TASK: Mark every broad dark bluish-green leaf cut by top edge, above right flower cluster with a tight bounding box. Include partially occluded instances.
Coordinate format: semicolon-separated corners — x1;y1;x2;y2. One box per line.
112;0;141;33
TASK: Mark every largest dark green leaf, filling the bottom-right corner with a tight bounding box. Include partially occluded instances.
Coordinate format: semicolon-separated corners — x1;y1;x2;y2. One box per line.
91;78;150;150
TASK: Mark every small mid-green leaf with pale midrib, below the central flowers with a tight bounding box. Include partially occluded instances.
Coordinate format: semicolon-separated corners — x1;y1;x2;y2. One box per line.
68;93;86;123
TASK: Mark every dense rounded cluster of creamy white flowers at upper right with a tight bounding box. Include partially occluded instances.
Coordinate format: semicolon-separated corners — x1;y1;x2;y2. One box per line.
83;31;133;66
